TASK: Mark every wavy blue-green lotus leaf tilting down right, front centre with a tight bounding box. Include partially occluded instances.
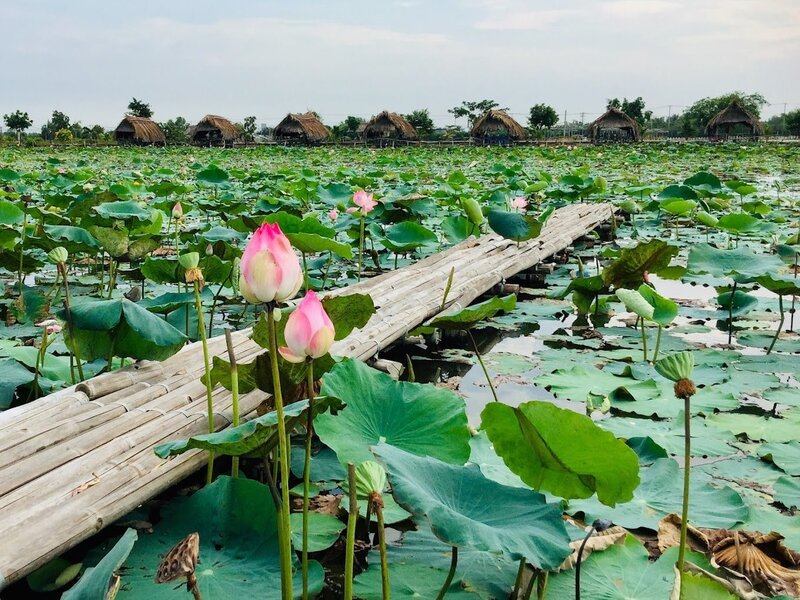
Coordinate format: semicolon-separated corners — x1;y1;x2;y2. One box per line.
374;444;569;569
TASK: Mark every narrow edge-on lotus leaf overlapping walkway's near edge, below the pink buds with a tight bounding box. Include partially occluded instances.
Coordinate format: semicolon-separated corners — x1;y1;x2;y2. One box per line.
155;397;341;458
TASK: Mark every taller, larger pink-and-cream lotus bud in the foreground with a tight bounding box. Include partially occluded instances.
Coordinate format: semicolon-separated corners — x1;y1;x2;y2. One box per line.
239;223;303;304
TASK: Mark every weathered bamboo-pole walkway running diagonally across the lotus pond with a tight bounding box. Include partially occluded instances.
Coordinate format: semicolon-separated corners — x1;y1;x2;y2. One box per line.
0;204;612;589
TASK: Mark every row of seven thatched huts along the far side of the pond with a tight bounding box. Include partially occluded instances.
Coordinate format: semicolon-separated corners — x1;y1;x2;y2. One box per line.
114;100;764;146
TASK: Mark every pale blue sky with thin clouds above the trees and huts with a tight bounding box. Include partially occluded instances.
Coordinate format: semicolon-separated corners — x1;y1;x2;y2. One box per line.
0;0;800;130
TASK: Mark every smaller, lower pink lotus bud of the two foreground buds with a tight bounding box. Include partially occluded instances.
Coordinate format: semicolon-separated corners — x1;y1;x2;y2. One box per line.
278;290;336;363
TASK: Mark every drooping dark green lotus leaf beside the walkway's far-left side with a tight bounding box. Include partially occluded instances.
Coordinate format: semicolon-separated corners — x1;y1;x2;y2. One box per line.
57;298;186;360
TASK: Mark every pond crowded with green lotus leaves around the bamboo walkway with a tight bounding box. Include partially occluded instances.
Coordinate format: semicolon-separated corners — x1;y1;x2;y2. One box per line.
0;144;800;600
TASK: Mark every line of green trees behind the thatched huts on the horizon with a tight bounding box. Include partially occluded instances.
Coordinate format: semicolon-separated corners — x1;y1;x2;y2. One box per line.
3;91;800;144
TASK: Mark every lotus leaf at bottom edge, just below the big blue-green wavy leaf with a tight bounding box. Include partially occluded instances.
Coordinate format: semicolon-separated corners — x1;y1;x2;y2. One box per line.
353;562;480;600
